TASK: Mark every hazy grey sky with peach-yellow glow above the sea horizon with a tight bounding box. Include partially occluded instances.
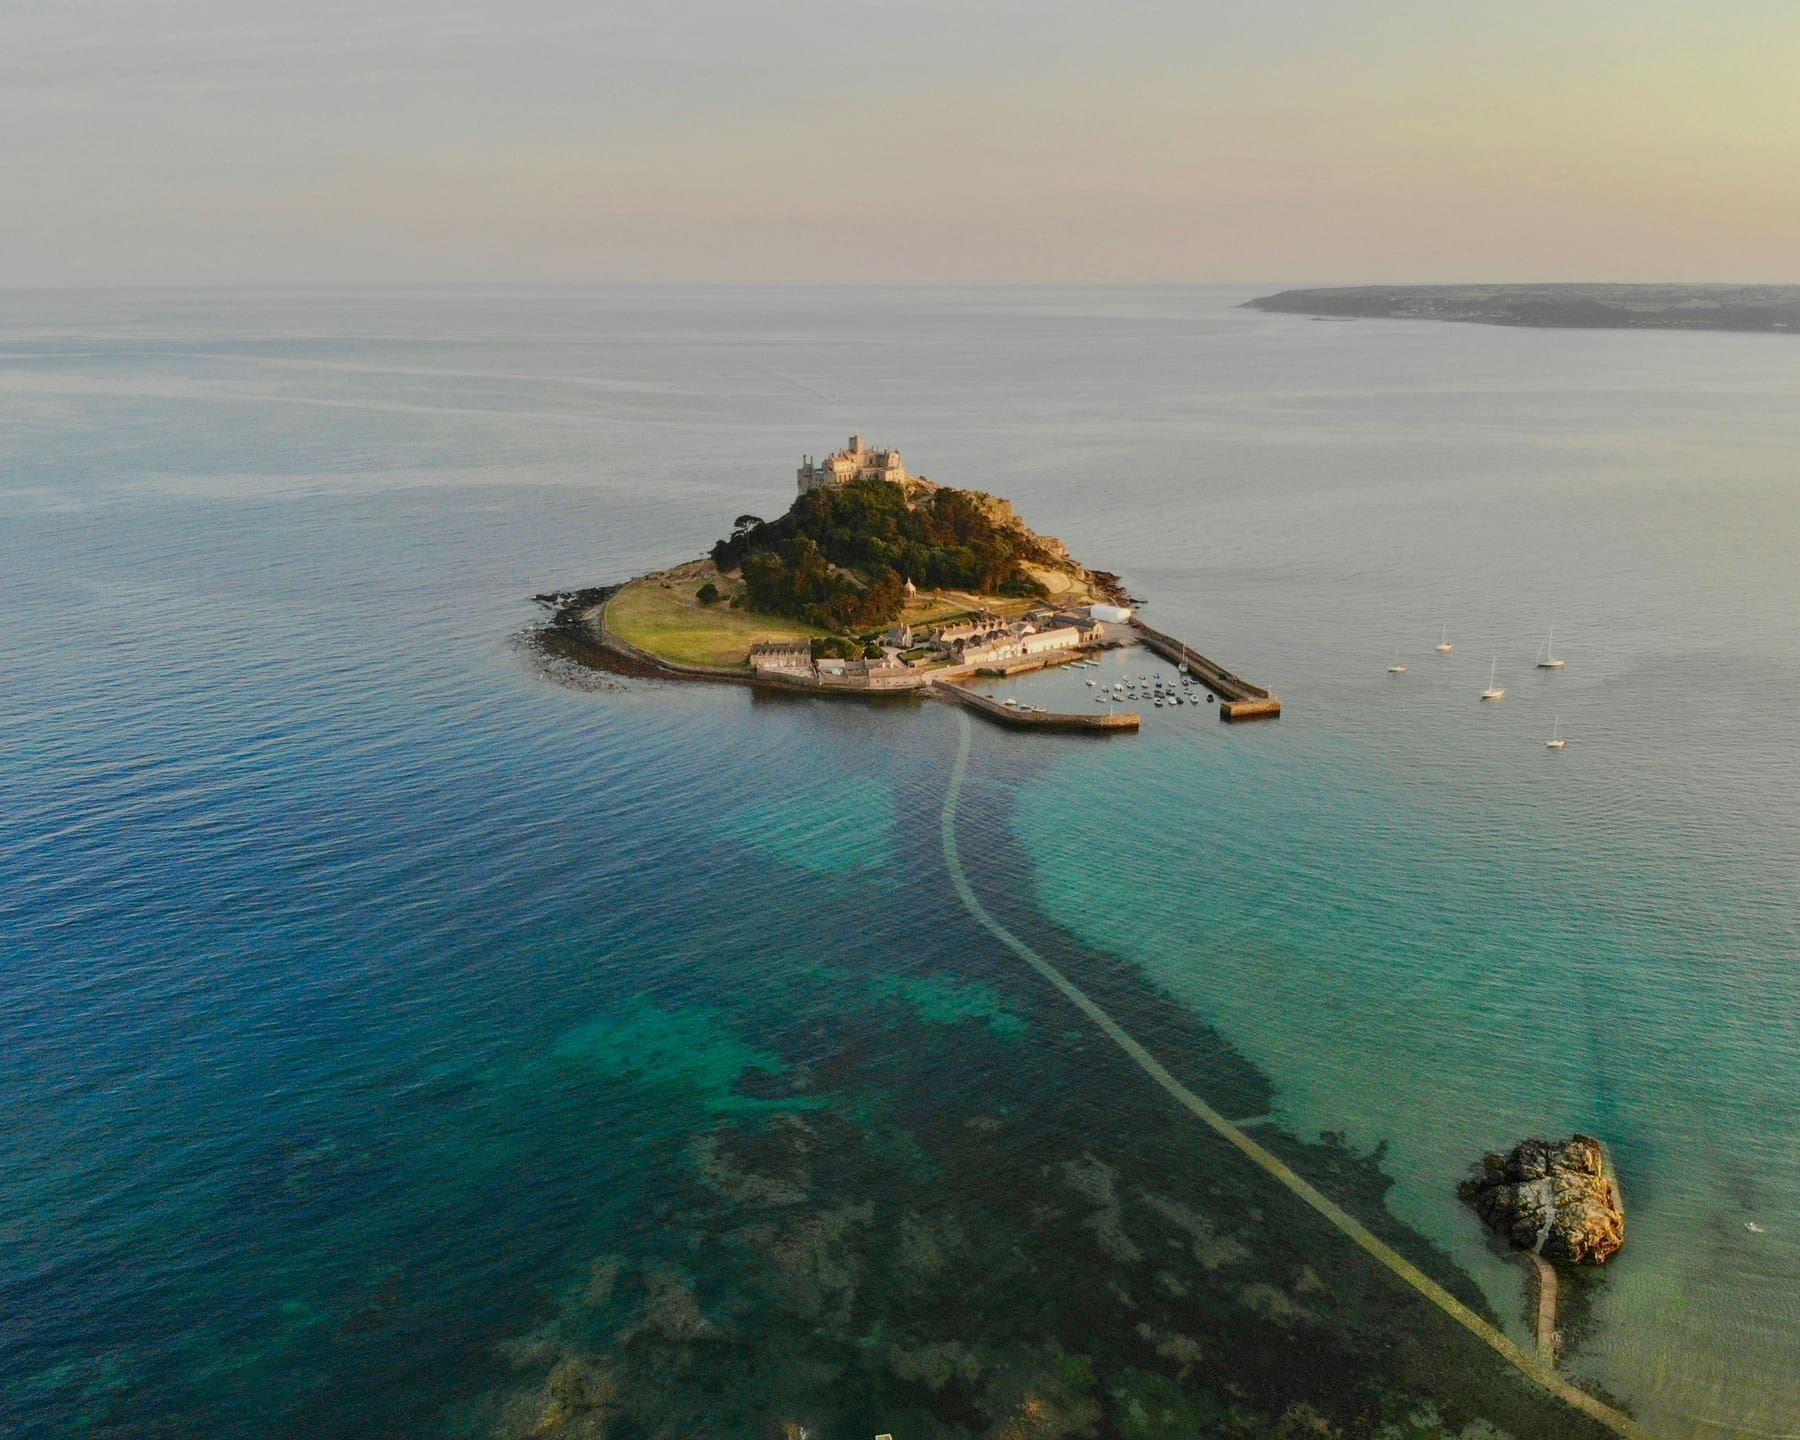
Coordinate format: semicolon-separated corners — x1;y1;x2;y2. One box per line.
0;0;1800;286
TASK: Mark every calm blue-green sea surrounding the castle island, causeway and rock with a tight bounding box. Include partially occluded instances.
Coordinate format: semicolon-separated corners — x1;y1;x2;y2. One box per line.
0;288;1800;1440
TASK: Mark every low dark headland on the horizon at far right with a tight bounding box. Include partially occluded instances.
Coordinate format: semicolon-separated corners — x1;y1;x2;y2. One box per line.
1247;284;1800;333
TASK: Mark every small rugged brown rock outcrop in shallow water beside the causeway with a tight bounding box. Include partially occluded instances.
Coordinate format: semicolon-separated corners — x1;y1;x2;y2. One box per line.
1456;1134;1625;1265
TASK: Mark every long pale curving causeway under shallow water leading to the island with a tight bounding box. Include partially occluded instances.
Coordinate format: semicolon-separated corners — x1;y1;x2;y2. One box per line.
940;711;1649;1440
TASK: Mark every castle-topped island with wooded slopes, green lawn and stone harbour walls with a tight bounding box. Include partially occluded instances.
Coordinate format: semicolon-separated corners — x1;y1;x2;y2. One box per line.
535;436;1282;733
